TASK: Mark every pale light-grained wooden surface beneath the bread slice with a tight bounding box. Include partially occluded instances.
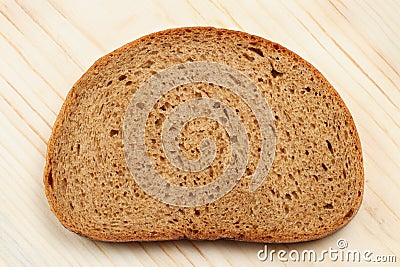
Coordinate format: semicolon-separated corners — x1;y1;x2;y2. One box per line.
0;0;400;266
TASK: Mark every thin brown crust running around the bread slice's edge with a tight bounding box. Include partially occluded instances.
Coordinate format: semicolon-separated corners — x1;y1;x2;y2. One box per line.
43;27;364;243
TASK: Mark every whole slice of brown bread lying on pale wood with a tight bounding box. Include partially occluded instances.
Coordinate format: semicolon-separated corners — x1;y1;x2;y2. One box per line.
44;27;364;242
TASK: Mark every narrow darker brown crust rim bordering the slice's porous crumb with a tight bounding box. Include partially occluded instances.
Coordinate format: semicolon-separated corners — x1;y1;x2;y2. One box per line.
43;27;364;243
